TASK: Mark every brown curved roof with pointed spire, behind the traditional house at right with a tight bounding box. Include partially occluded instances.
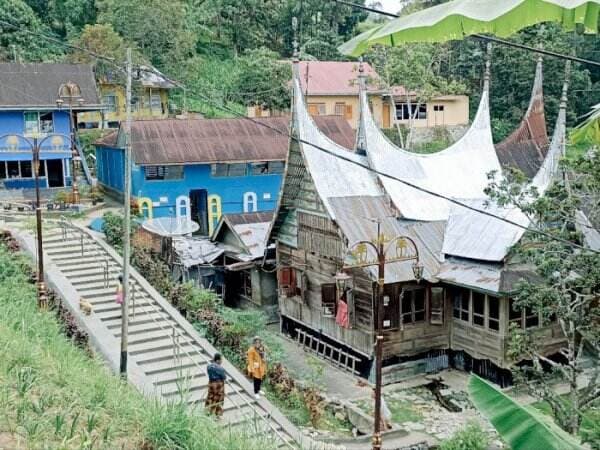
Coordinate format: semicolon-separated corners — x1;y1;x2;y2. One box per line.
496;58;550;178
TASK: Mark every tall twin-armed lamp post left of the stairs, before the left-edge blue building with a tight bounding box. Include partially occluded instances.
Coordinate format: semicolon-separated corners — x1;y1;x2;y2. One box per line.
0;133;71;308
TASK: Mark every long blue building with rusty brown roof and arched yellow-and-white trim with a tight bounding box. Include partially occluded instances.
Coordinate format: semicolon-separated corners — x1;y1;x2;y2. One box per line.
96;116;354;235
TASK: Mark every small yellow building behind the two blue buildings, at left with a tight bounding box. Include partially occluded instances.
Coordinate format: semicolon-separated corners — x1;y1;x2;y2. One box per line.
77;70;176;129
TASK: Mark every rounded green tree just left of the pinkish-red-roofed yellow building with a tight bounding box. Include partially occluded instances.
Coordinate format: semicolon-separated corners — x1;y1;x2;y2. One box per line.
237;48;292;110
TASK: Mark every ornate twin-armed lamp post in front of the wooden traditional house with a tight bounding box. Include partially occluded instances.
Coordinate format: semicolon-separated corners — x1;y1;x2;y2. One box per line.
335;221;423;450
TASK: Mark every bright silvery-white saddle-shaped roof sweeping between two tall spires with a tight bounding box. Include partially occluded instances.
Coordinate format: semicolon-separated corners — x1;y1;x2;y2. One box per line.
359;67;501;221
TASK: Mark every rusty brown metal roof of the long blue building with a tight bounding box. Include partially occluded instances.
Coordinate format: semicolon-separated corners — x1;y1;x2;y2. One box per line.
96;116;354;165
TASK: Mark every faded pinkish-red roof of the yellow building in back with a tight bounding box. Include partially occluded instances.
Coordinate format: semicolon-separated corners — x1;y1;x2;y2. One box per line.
300;61;379;95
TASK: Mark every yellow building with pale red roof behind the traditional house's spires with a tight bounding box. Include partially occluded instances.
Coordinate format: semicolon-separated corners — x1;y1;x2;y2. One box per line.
248;61;469;129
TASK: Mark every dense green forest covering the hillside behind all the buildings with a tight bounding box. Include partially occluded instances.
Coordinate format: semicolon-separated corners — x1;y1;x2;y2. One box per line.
0;0;600;139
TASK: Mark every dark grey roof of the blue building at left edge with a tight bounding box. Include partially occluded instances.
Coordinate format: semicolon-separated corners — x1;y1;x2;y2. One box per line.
0;63;100;110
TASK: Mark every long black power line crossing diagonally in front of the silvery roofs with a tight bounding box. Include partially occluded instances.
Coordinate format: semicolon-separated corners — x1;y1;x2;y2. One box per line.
0;14;600;254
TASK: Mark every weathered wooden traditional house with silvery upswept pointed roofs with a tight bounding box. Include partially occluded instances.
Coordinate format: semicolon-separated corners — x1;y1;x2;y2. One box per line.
270;51;567;385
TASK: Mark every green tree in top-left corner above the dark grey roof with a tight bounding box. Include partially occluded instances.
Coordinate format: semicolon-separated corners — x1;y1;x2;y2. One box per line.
0;0;61;61
